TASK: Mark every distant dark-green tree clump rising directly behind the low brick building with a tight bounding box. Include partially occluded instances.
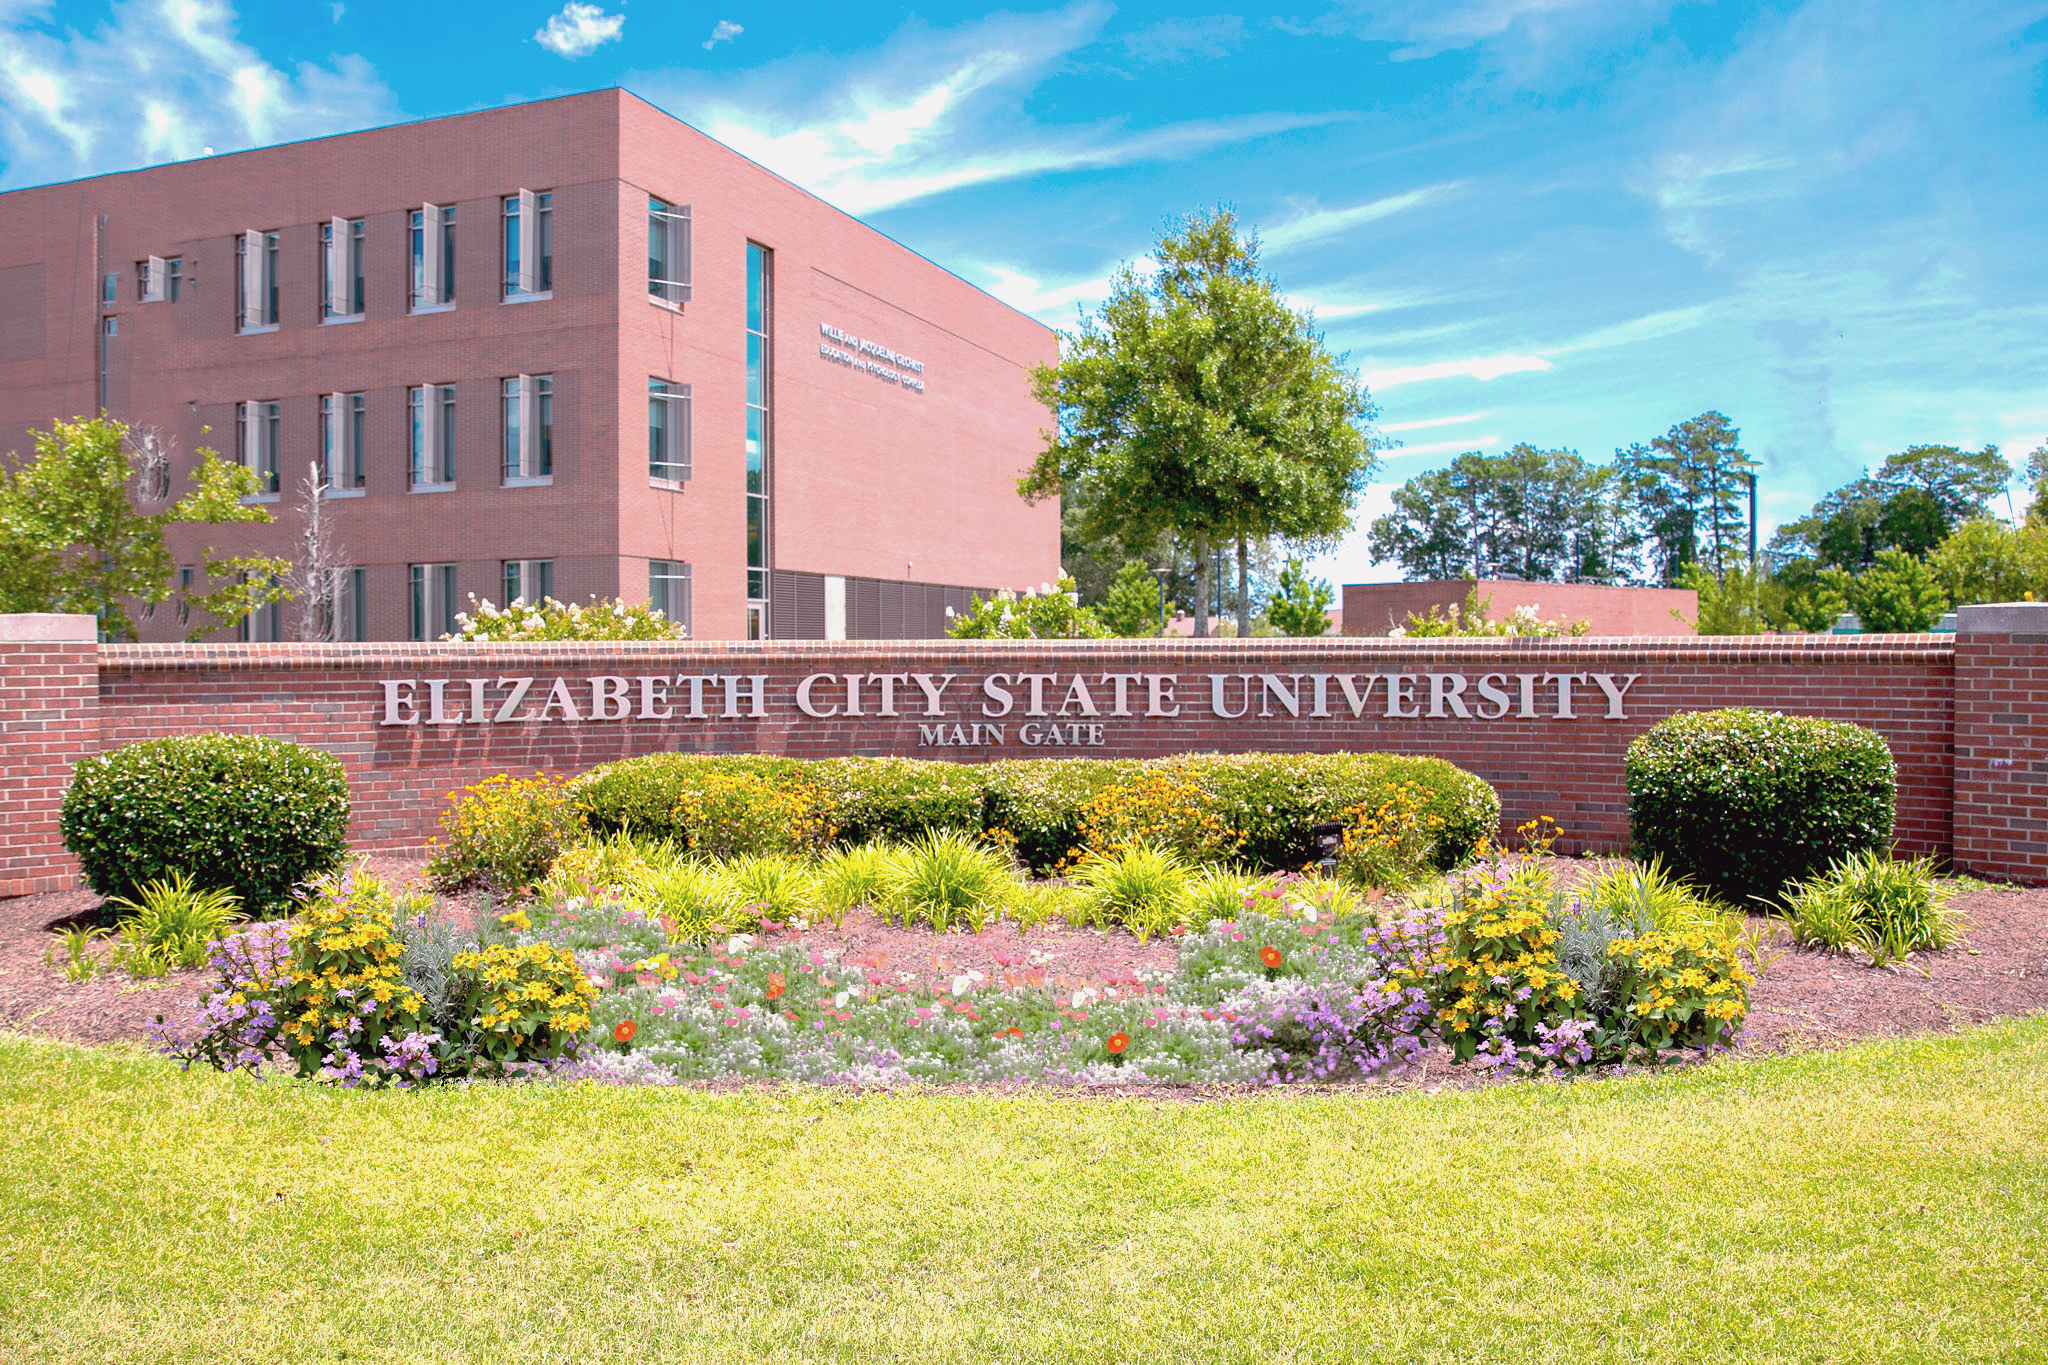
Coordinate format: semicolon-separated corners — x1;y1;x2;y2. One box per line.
1370;442;1634;583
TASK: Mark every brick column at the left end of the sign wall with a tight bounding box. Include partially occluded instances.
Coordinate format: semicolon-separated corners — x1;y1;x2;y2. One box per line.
0;614;100;896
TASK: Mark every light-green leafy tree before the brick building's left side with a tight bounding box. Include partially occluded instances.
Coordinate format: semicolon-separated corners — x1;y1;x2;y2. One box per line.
0;417;289;641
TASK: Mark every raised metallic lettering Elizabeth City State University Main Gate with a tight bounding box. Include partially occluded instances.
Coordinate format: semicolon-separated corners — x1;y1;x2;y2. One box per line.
379;669;1642;747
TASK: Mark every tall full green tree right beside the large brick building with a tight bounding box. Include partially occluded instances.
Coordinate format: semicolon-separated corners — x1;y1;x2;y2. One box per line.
1018;209;1376;634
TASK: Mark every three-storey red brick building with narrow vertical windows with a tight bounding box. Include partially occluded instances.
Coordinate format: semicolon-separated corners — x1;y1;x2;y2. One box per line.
0;90;1059;641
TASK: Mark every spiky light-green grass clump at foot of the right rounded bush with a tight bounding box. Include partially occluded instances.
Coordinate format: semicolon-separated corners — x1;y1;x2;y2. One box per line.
1786;849;1962;966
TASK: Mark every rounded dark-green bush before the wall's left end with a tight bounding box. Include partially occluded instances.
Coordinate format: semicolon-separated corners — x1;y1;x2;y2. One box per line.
59;735;348;915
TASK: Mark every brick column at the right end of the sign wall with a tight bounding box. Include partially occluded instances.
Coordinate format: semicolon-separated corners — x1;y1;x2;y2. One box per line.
1956;602;2048;884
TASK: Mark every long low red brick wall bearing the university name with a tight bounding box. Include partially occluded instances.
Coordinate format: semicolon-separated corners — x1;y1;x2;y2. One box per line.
0;606;2048;890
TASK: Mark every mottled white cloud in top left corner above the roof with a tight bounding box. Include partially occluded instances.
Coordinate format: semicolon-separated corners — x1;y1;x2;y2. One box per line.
0;0;397;186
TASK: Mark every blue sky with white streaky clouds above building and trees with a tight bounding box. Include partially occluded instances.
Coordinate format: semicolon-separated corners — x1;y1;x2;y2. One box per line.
0;0;2048;581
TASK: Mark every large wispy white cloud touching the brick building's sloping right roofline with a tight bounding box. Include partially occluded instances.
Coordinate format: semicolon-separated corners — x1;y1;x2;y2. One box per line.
631;0;1350;213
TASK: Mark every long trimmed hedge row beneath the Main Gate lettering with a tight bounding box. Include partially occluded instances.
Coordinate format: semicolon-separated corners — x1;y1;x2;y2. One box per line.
571;753;1501;872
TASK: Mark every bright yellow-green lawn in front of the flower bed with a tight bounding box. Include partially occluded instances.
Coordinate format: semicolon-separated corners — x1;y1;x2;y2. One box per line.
0;1017;2048;1365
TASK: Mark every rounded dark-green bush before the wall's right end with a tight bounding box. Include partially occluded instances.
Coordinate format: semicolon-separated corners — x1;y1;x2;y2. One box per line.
1624;708;1898;905
